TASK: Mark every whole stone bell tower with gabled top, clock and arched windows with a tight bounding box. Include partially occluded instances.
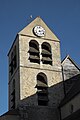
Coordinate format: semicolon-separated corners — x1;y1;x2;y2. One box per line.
8;17;64;120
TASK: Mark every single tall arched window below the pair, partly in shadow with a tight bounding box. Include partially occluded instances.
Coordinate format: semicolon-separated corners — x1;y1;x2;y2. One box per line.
36;73;48;106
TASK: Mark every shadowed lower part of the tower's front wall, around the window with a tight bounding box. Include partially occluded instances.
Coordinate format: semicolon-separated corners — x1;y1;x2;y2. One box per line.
15;79;64;120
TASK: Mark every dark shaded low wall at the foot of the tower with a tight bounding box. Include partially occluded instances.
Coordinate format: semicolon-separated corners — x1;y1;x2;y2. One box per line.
19;106;60;120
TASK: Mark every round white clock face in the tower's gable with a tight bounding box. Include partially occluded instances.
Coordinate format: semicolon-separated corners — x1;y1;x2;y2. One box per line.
33;26;45;37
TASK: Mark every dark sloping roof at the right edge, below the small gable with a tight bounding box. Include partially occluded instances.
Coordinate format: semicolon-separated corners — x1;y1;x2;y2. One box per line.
60;74;80;107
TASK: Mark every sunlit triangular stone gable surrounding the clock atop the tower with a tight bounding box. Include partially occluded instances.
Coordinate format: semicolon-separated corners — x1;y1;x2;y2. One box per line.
18;17;59;41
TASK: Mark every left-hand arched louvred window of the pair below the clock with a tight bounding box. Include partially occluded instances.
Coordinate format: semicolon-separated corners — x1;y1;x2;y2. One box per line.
29;40;40;63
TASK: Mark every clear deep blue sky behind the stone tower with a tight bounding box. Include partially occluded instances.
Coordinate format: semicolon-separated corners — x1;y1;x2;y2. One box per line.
0;0;80;115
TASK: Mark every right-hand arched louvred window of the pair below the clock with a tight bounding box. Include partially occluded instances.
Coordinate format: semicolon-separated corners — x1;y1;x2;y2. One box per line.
42;42;52;65
